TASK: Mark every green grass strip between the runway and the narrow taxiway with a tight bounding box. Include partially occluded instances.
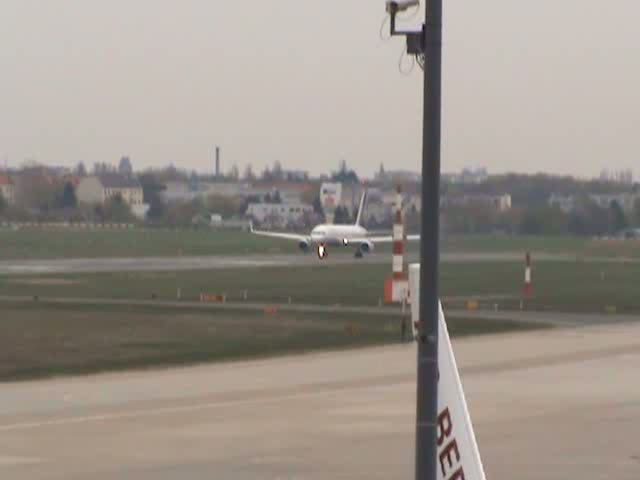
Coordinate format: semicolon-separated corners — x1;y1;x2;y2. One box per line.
0;261;640;313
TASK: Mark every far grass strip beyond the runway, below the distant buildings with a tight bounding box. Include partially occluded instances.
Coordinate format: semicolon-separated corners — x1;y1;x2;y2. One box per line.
0;228;640;260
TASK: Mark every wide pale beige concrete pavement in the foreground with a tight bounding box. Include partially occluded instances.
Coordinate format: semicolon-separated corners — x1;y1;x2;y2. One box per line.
0;325;640;480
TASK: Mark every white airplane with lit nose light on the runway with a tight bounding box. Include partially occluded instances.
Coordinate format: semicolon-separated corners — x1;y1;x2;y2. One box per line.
250;191;420;260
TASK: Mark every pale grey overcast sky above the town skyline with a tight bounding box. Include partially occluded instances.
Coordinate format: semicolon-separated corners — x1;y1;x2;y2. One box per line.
0;0;640;176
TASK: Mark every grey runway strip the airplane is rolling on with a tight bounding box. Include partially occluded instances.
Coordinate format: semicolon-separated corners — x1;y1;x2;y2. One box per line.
0;252;638;275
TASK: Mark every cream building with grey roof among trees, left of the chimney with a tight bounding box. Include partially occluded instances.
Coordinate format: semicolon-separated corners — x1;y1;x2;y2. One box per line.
76;173;143;207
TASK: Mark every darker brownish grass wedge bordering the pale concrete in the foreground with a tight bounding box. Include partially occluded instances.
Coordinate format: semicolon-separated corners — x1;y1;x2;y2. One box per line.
0;303;539;381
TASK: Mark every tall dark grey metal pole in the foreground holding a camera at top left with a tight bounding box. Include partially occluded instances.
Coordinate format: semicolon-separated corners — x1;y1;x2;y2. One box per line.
416;0;442;480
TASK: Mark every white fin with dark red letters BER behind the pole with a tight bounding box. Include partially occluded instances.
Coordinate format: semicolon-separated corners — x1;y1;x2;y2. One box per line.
409;264;485;480
